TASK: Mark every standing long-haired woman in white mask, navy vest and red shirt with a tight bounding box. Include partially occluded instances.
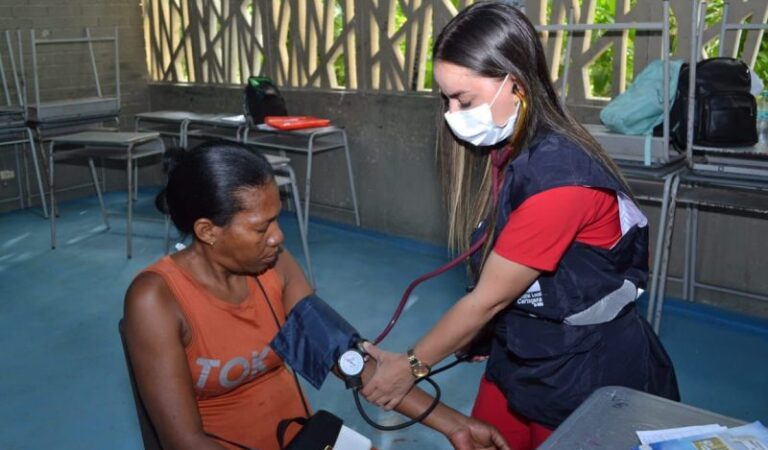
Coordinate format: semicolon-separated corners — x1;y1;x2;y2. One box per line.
362;2;679;450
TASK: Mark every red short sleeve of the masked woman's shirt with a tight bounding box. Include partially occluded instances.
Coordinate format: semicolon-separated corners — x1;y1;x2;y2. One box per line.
494;186;621;272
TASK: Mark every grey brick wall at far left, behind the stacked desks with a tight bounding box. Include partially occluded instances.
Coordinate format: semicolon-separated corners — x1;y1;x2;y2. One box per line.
0;0;151;210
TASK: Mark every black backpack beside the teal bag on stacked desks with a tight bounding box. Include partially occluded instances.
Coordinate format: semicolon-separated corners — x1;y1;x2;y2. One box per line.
669;58;757;150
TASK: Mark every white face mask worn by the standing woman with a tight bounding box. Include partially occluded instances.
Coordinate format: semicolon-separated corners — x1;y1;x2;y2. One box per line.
444;74;520;146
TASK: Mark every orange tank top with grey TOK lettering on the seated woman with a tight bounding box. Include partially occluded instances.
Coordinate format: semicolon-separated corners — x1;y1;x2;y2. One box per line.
146;256;305;450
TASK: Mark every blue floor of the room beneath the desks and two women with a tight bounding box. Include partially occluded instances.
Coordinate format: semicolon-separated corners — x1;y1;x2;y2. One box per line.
0;191;768;450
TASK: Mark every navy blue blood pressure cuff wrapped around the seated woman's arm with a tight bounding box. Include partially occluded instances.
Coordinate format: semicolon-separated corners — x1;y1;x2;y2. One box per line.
269;295;360;389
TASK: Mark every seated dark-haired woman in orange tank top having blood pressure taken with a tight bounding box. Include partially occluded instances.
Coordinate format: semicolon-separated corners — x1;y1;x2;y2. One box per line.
124;143;507;450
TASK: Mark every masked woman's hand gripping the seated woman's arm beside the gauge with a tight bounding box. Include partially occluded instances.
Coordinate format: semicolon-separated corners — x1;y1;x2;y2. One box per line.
360;342;416;410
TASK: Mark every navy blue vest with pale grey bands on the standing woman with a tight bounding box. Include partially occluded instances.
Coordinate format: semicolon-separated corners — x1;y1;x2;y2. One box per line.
486;133;679;427
